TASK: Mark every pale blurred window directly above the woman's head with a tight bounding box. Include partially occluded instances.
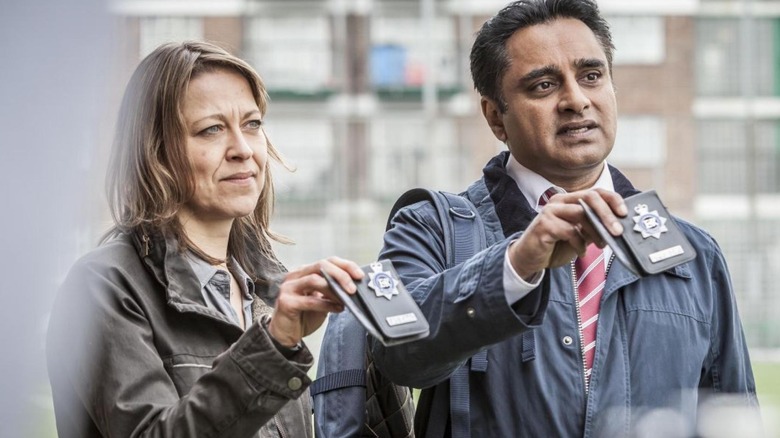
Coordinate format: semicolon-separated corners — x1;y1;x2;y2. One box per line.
139;17;203;58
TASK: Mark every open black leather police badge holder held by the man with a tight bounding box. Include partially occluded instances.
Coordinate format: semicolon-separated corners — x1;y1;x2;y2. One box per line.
580;190;696;276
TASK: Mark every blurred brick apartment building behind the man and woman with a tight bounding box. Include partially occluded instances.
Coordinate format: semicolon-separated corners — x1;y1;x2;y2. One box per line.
105;0;780;348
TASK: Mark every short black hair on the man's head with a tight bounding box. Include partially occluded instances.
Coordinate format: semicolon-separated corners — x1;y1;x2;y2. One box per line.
471;0;615;112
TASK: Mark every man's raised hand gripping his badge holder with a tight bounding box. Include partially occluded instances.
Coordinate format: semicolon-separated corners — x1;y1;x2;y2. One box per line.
509;189;628;280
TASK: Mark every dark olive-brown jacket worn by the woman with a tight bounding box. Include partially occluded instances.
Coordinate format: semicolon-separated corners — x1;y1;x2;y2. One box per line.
47;229;313;438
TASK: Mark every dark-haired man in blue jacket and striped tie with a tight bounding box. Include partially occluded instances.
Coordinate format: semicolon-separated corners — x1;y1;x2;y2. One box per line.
372;0;756;437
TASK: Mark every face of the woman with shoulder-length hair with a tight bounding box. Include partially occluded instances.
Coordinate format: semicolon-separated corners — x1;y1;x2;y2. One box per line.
180;68;268;227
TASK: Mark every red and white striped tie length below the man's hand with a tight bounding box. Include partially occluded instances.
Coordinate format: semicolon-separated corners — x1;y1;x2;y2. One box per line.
574;244;606;382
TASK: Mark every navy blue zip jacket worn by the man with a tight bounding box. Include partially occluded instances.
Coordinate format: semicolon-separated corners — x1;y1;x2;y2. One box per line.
372;152;757;437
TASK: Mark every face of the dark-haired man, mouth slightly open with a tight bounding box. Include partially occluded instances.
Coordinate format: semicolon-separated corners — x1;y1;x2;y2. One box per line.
482;19;617;190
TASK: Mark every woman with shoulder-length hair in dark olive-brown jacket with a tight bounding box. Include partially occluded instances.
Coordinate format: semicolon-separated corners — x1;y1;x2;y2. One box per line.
47;43;363;438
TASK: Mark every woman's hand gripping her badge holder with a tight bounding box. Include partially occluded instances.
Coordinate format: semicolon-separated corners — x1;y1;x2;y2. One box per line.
268;257;364;347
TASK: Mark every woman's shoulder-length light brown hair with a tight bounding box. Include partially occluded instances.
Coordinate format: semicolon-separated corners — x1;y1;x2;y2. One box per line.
106;42;287;275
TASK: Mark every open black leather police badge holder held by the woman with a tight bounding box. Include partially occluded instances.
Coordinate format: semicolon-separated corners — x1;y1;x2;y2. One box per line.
322;260;430;346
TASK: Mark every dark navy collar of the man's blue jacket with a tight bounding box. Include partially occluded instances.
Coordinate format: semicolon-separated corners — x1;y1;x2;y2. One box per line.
482;151;639;240
